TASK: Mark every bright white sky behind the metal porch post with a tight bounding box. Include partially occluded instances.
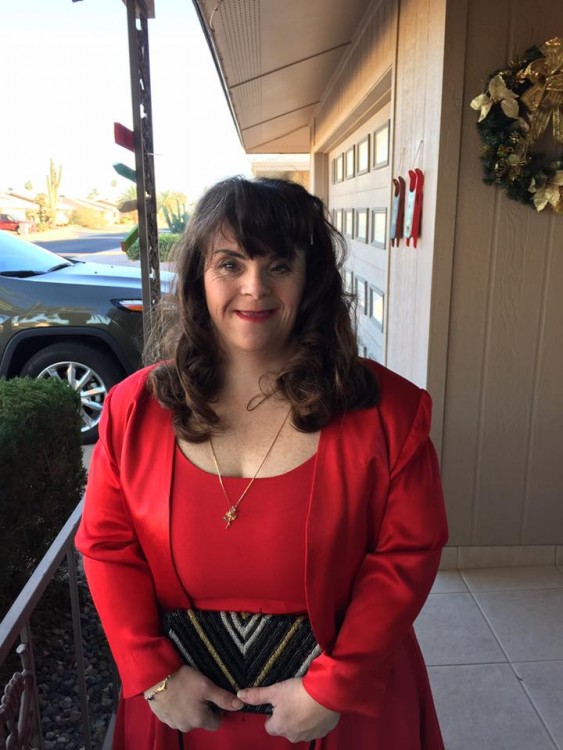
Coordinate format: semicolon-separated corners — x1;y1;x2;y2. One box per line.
0;0;249;199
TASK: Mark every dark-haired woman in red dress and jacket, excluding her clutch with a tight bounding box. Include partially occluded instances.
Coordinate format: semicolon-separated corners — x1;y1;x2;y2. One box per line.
77;178;446;750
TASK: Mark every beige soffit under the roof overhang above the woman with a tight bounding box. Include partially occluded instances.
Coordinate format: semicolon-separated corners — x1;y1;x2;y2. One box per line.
193;0;371;153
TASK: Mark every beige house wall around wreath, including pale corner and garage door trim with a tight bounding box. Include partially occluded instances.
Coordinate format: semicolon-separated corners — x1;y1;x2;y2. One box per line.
311;0;563;554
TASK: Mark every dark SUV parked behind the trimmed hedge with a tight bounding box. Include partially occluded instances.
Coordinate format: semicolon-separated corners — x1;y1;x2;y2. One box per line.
0;231;171;443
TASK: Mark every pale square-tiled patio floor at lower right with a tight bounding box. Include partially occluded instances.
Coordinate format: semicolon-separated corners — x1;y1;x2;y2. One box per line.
415;566;563;750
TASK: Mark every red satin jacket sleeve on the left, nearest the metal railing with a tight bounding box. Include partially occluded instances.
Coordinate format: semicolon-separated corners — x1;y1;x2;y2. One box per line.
76;392;182;698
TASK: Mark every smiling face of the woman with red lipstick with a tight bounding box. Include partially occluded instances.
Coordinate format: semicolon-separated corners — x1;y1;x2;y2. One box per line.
203;231;305;358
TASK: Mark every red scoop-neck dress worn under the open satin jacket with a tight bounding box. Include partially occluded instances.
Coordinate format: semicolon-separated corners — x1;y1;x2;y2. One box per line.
116;448;438;750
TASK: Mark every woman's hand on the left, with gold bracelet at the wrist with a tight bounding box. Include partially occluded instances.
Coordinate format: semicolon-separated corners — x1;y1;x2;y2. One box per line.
144;666;243;732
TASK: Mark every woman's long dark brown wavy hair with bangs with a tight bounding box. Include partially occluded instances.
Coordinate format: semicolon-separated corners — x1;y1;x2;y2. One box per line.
147;177;378;442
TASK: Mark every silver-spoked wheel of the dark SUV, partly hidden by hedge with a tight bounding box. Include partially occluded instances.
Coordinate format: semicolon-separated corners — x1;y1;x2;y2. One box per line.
20;344;123;443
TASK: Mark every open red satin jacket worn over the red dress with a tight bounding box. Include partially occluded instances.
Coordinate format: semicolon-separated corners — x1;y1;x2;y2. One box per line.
76;363;447;749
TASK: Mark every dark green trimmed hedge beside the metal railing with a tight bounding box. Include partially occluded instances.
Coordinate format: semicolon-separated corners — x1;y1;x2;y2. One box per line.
0;378;85;616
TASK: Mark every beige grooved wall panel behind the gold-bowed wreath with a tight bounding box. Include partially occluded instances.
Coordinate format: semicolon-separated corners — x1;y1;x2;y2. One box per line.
442;0;563;545
